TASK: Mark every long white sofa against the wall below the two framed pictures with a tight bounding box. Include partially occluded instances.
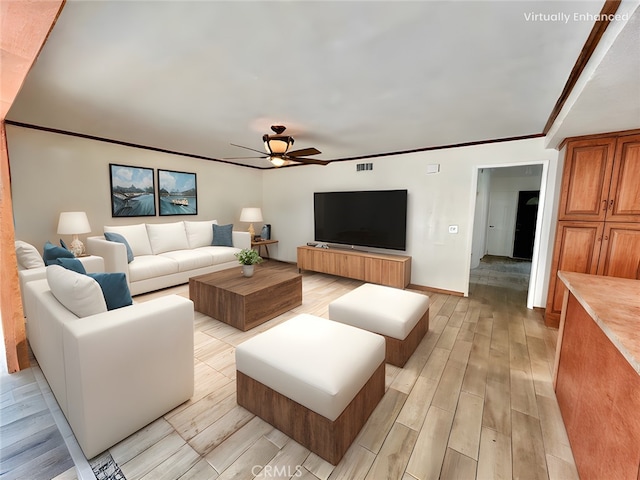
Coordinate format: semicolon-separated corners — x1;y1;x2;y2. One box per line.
86;220;251;295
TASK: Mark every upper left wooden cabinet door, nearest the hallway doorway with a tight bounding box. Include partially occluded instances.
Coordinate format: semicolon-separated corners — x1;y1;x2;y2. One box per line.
558;138;616;221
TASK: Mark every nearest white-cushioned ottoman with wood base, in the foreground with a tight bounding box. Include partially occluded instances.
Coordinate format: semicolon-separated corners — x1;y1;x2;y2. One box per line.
236;314;385;465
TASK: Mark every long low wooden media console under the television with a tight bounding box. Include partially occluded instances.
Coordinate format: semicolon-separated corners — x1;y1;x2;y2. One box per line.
298;246;411;288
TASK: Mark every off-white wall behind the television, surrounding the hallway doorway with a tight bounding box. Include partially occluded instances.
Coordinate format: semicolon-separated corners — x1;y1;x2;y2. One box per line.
263;138;558;306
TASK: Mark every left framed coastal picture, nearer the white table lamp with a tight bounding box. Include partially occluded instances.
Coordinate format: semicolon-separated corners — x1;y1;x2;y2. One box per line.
109;163;156;217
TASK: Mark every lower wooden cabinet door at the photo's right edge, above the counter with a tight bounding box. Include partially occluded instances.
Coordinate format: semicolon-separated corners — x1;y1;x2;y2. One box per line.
598;222;640;280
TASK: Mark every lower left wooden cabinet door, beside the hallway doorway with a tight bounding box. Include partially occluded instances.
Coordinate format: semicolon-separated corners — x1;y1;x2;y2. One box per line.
545;222;604;327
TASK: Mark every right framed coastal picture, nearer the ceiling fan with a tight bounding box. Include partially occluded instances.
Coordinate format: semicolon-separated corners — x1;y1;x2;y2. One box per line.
158;169;198;215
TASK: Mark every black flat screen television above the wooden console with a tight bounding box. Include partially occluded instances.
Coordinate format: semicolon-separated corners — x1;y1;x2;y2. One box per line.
313;190;407;250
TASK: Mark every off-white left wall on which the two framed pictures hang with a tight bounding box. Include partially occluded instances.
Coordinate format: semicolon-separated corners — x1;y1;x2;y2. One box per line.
7;125;262;251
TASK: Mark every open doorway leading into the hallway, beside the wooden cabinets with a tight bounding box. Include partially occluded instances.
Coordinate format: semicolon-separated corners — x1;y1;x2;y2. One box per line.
469;164;543;306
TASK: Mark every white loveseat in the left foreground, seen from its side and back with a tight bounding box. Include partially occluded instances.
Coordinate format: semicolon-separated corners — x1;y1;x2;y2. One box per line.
24;265;194;458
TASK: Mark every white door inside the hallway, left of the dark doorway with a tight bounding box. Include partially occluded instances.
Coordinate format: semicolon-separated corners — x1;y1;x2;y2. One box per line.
487;192;516;257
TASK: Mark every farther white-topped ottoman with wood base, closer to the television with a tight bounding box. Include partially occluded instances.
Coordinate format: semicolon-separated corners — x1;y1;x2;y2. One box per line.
329;283;429;367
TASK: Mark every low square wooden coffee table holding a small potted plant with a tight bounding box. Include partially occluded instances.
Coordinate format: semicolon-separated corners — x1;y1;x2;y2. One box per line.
189;266;302;332
